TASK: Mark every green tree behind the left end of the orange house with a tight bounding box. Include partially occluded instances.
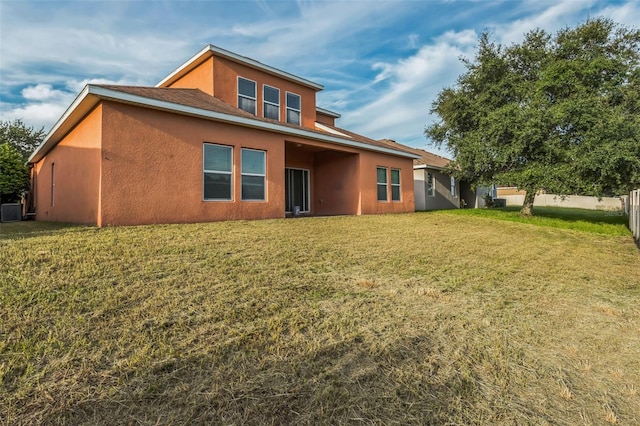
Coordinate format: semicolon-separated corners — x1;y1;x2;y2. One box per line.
0;119;44;203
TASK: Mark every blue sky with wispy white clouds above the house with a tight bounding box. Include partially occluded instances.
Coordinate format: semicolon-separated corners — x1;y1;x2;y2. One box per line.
0;0;640;155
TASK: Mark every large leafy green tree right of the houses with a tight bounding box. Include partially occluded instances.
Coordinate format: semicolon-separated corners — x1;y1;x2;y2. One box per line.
425;18;640;214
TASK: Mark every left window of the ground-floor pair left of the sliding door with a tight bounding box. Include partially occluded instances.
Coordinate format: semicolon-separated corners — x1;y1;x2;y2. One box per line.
202;143;233;201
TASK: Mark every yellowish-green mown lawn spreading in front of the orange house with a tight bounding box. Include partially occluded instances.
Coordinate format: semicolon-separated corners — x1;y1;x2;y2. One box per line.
0;215;640;425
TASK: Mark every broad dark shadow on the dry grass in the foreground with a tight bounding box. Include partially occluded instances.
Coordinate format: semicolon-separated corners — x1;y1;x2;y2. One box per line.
41;336;520;425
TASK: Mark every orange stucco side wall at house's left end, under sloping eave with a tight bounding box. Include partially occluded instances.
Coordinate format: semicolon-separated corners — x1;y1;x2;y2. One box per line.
32;106;102;224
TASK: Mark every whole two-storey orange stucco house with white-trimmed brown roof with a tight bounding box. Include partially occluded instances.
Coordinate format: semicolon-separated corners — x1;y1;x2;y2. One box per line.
27;45;417;226
